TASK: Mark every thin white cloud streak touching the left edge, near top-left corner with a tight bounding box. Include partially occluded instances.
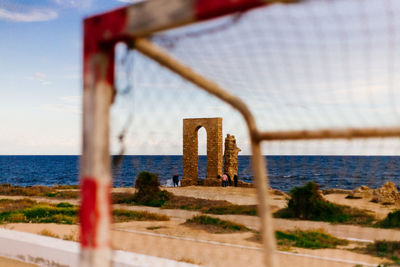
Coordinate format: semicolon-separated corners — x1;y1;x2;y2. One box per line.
0;8;58;22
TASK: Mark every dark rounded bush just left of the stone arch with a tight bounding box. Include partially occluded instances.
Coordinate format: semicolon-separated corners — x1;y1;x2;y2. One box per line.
133;171;170;207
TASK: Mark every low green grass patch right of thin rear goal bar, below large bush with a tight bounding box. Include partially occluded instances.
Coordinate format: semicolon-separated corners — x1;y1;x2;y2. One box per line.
275;230;349;249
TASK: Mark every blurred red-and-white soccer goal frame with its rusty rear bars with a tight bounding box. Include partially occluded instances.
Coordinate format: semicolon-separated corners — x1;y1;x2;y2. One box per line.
80;0;400;266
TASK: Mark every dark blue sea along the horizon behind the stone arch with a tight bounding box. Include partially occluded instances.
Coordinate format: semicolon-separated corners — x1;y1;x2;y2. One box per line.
0;155;400;192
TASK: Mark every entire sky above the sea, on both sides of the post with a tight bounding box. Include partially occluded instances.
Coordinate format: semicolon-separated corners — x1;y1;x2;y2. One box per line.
0;0;400;155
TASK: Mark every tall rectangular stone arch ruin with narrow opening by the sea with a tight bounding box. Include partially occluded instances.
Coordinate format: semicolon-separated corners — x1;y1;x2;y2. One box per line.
181;118;222;186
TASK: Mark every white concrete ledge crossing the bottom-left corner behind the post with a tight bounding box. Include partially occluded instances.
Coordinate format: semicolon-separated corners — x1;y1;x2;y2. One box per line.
0;228;198;267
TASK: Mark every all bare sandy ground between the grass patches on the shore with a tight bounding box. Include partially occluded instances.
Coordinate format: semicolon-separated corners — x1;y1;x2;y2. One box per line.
0;187;400;266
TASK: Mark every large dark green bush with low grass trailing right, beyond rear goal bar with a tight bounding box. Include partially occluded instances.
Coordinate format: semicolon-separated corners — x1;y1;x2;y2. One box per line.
274;182;375;225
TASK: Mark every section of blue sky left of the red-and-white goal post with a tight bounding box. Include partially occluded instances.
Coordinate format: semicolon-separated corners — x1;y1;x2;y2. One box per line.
0;0;136;154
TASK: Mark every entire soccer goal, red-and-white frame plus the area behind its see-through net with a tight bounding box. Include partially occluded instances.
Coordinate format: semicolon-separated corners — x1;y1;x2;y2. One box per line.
81;0;400;266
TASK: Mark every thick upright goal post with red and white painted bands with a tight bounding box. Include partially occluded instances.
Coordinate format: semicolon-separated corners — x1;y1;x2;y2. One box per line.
80;17;114;267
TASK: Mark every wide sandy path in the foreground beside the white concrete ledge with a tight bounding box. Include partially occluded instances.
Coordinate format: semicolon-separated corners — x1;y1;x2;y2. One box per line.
3;224;382;267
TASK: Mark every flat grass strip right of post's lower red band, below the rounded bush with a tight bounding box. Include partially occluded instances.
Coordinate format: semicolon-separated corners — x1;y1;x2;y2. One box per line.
113;209;169;222
